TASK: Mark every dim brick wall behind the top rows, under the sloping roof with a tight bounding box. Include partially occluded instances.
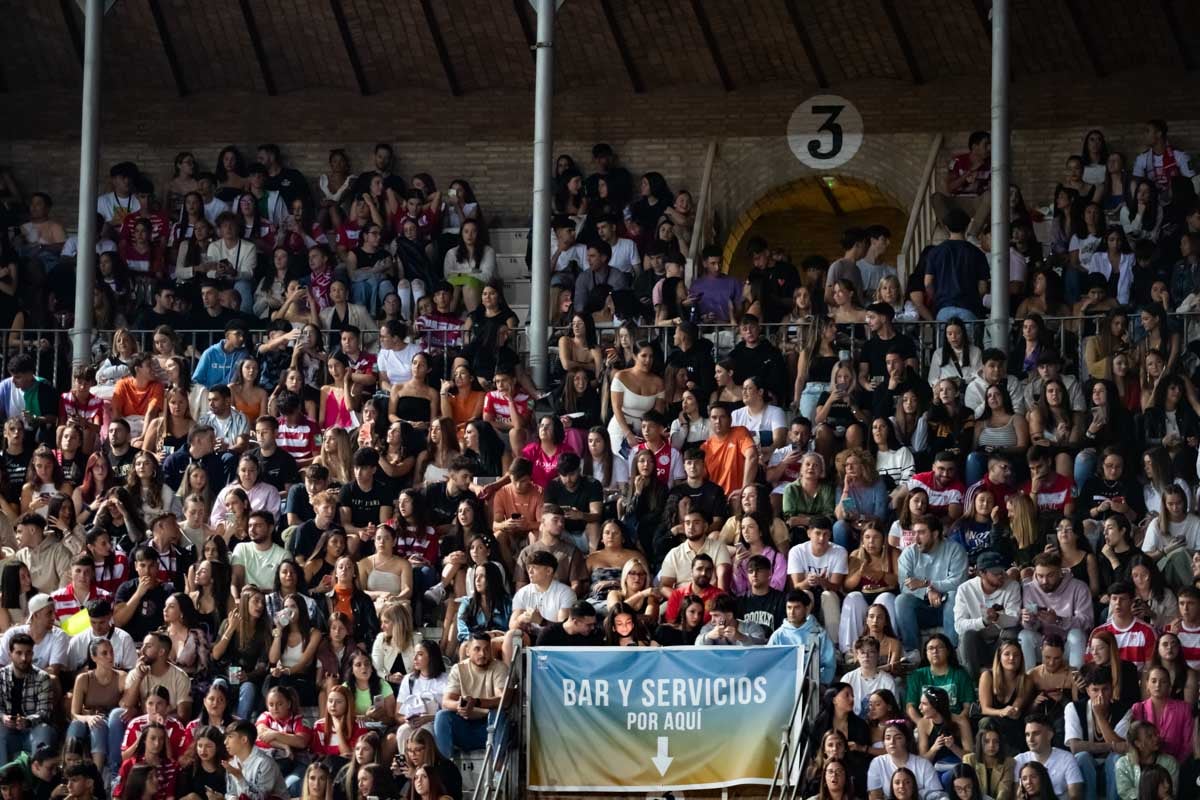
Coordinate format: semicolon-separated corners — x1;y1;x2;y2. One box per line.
0;73;1200;253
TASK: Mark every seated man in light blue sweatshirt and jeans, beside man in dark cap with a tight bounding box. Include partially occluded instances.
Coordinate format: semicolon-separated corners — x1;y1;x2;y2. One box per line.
896;515;967;662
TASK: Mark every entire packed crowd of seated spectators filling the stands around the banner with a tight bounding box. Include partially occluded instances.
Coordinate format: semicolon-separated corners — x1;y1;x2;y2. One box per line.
0;120;1200;800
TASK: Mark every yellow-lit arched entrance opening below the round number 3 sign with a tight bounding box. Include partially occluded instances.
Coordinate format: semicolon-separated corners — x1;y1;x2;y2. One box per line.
725;175;908;276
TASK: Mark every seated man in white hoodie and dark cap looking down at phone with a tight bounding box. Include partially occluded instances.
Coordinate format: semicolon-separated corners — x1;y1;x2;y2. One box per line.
954;551;1021;675
